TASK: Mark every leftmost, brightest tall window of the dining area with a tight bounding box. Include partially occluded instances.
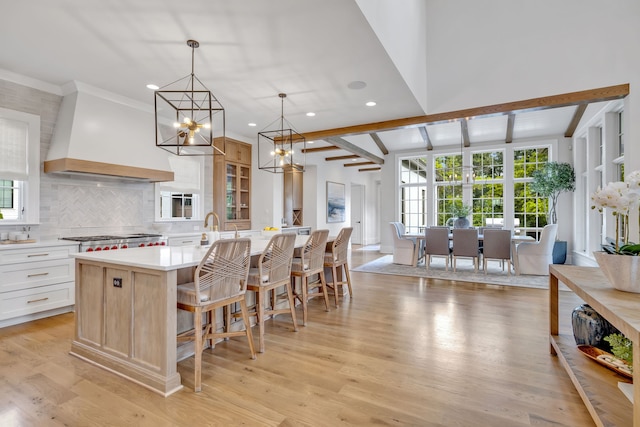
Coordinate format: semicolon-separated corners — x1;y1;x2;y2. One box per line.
400;157;427;233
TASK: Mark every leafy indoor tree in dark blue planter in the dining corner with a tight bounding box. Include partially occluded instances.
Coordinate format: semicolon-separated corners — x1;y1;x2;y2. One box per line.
530;162;576;264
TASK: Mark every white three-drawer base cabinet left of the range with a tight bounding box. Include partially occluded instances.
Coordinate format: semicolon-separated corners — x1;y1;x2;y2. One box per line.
0;242;78;327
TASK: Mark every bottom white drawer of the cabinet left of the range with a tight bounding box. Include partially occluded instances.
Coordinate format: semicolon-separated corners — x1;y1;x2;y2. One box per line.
0;282;75;320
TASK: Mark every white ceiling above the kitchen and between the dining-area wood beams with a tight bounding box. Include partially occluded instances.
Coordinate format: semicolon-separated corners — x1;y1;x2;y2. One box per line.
0;0;608;168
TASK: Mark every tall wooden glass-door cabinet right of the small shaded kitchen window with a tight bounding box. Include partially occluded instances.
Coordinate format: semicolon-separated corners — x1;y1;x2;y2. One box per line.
213;138;251;231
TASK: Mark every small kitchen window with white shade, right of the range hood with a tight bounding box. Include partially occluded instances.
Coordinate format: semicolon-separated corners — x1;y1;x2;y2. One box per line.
156;156;204;220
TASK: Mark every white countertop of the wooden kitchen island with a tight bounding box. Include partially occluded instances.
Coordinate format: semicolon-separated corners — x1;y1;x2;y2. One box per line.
72;236;309;271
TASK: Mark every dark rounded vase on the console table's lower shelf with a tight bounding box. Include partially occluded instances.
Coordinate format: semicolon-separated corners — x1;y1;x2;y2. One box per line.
571;304;619;351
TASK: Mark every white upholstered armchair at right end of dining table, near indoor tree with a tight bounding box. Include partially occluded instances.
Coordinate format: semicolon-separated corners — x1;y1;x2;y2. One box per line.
515;224;558;276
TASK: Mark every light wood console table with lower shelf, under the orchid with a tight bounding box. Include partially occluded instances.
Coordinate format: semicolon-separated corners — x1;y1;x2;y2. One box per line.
549;265;640;427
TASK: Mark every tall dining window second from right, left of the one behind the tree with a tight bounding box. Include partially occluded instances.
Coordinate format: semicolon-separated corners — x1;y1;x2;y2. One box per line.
471;151;504;227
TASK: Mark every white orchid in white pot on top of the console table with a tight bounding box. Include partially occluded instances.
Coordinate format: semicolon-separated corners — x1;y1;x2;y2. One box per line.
591;170;640;293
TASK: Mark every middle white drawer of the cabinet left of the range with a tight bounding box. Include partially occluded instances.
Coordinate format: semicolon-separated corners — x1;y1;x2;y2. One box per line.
0;259;75;292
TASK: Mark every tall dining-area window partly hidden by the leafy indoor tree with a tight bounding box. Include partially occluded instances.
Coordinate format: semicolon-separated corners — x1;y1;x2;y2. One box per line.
513;147;550;237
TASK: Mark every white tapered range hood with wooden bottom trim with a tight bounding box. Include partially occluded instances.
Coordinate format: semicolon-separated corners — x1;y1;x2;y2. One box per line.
44;82;173;182
